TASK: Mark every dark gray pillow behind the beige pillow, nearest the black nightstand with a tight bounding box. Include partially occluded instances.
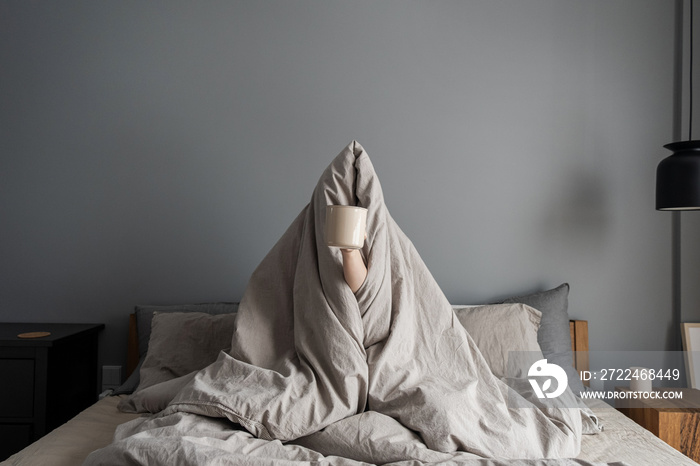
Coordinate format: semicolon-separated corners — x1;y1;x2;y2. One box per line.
112;302;238;395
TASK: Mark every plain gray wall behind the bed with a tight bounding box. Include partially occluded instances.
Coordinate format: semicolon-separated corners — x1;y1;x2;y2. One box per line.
0;0;688;376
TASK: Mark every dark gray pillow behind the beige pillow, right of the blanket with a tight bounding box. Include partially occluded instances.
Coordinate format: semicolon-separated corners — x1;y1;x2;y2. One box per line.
504;283;585;395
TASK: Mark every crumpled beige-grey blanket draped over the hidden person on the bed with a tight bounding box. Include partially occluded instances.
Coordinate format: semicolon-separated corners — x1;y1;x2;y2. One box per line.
86;142;612;464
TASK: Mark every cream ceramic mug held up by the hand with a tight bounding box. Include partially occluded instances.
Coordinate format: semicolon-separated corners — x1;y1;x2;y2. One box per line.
326;205;367;249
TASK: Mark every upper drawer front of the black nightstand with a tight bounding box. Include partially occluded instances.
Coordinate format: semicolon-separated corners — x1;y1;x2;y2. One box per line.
0;359;34;416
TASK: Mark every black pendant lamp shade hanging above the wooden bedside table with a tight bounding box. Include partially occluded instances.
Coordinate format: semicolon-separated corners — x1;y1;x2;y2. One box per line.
656;141;700;210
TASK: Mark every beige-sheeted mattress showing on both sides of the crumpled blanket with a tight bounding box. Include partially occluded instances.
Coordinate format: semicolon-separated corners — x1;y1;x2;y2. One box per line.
0;396;698;466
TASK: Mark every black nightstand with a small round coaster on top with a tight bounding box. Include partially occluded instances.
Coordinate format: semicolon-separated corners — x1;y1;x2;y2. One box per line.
0;323;104;461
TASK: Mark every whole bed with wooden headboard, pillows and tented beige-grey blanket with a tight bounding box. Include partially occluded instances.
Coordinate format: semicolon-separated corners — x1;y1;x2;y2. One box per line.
8;142;695;466
